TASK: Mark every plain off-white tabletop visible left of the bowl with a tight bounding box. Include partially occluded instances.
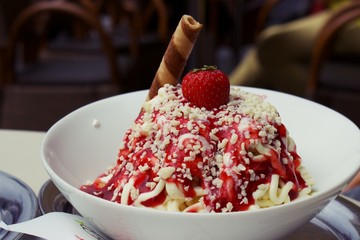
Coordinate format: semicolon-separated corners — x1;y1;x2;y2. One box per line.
0;129;49;195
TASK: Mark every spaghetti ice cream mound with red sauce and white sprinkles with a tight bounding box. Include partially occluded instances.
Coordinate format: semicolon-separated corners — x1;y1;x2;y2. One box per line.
81;84;313;212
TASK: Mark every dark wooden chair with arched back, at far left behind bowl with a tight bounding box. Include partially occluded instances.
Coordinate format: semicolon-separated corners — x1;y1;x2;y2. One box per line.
0;1;123;130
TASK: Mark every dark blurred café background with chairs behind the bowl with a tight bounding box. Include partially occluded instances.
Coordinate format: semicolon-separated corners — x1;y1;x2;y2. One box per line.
0;0;360;131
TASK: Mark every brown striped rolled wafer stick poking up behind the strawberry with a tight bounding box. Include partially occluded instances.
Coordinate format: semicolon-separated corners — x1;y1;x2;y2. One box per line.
147;15;202;100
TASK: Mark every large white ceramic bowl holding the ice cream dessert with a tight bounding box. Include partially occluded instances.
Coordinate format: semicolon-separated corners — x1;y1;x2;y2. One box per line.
41;88;360;240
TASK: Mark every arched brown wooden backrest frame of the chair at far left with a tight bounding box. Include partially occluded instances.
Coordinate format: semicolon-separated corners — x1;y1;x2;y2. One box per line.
5;1;121;85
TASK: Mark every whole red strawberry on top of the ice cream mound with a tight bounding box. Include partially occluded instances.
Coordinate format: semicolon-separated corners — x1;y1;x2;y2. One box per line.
182;65;230;110
